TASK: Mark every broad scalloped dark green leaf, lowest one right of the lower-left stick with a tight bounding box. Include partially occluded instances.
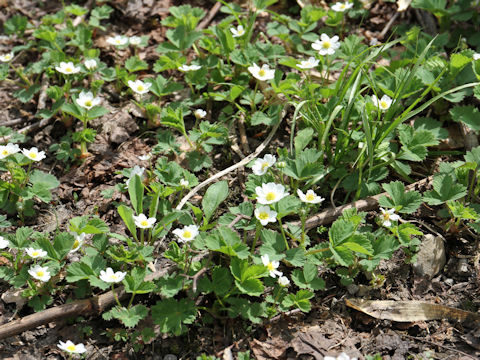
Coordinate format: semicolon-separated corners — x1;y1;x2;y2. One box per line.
152;299;197;336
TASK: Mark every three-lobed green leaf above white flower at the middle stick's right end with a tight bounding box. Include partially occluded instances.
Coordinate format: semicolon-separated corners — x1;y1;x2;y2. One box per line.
378;181;422;214
